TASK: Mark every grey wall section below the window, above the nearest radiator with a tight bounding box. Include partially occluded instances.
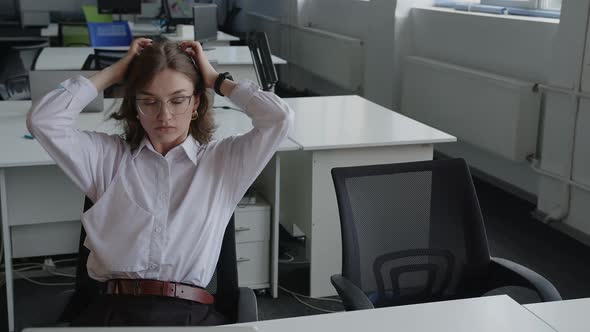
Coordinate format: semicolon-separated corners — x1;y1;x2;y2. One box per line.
412;9;559;87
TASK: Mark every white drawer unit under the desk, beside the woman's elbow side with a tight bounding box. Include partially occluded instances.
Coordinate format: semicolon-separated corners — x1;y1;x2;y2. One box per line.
235;196;271;289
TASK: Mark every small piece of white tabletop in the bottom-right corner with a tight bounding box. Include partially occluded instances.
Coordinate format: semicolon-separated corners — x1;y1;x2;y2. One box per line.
525;298;590;332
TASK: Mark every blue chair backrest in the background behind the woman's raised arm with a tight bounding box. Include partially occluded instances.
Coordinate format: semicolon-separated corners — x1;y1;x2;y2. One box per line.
87;21;133;47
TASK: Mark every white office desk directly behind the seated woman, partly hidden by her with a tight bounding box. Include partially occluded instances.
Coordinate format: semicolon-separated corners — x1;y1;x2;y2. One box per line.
0;97;299;331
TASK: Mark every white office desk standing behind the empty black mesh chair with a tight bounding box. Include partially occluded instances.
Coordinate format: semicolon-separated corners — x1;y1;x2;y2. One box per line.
280;96;456;297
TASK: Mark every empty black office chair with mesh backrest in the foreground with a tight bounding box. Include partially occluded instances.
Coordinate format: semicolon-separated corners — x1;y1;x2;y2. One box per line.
331;159;561;310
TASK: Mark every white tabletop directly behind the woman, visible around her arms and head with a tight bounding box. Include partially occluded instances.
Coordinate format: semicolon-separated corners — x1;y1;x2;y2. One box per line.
0;97;300;168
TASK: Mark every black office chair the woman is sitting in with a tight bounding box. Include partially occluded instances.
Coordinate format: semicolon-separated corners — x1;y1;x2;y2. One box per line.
58;198;258;326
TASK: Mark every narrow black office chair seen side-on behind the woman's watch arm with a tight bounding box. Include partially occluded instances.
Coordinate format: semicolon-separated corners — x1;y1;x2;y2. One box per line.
246;32;279;91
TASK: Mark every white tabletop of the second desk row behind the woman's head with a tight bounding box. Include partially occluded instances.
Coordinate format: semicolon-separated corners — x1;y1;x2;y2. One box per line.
35;46;287;70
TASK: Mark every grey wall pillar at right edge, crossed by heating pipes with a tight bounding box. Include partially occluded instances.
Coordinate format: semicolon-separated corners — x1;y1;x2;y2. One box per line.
538;0;590;239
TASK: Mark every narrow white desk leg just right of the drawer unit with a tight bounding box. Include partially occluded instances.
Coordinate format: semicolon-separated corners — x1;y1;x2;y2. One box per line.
255;153;281;298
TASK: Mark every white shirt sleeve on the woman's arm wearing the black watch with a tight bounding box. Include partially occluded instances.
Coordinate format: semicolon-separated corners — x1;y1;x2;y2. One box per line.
220;81;293;204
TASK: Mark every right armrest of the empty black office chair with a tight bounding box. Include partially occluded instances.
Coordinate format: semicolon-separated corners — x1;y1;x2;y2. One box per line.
490;257;561;302
